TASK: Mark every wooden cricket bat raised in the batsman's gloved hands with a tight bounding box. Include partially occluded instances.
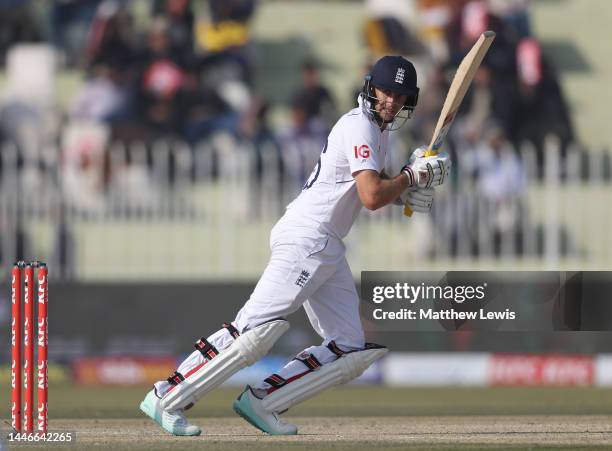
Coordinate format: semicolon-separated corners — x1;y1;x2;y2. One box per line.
404;31;495;216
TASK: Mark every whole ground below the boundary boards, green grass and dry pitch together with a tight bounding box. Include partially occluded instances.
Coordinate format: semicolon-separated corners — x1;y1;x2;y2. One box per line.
0;387;612;451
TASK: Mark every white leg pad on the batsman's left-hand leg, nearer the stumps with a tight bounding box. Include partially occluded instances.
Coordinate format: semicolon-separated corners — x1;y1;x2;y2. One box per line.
160;319;289;410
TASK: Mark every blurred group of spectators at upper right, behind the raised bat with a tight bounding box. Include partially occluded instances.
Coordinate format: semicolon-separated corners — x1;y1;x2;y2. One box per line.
364;0;574;167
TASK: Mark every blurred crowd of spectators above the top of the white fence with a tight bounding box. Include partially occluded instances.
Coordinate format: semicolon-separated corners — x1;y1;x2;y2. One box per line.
0;0;574;203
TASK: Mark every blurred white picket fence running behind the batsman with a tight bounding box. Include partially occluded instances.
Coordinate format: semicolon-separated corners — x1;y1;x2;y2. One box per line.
0;129;612;280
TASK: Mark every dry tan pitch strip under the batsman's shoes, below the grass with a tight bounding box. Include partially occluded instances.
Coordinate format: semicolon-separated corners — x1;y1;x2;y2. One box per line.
33;416;612;450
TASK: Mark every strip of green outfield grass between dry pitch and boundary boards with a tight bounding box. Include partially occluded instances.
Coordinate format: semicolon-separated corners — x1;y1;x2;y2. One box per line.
0;385;612;419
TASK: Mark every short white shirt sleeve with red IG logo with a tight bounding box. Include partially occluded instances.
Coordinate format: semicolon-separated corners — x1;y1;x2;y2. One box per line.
343;117;385;174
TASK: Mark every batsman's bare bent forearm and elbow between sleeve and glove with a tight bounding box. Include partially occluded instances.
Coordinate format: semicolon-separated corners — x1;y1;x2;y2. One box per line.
353;169;409;210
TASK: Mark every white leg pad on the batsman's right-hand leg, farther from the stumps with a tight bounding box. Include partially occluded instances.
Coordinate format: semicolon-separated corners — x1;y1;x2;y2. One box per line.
262;347;389;412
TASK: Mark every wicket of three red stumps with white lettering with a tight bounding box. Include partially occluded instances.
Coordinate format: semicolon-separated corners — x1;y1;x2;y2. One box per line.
11;261;49;433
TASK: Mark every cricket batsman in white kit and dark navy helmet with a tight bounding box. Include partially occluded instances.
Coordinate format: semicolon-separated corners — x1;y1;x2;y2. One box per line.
140;56;451;435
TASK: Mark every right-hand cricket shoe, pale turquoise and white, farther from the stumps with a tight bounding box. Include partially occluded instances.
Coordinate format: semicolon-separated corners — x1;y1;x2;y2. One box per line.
234;385;297;435
